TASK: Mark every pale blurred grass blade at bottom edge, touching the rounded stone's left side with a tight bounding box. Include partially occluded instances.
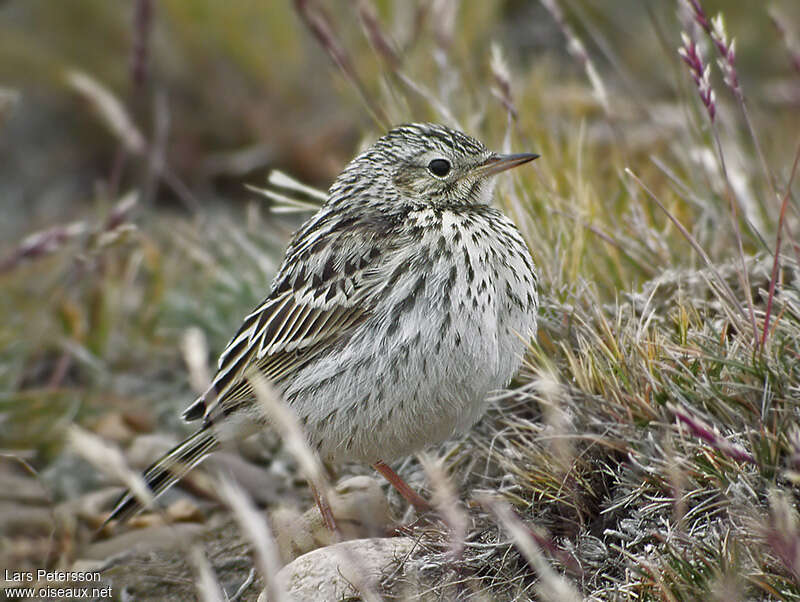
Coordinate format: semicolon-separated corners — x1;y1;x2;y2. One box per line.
220;479;287;602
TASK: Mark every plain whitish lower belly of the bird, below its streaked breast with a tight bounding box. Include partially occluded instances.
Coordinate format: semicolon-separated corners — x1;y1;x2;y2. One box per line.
286;311;494;463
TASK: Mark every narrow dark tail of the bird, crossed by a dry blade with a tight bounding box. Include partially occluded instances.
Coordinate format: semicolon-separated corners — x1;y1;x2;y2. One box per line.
104;424;219;524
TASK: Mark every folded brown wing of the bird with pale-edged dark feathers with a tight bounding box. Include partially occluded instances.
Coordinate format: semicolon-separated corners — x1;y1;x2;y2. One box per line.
183;213;388;421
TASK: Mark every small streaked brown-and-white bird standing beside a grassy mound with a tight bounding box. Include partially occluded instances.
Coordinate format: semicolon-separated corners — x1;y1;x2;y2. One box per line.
106;123;539;527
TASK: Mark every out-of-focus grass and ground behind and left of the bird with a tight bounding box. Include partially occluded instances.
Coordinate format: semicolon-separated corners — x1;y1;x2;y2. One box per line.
0;0;800;596
